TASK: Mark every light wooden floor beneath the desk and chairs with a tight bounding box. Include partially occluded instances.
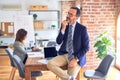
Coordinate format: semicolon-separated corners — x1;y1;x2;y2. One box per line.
0;56;120;80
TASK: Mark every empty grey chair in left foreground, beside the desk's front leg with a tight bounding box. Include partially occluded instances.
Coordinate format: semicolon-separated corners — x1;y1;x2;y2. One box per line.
13;55;42;80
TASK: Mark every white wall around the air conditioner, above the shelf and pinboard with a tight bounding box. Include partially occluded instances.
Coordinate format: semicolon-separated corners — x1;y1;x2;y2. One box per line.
0;0;61;22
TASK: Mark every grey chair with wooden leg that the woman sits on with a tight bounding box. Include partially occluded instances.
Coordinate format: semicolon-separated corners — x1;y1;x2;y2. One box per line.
5;48;17;80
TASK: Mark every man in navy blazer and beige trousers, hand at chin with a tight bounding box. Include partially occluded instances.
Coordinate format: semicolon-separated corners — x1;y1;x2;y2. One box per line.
47;7;89;80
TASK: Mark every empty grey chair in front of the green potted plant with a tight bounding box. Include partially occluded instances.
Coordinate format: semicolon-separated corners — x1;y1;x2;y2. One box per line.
84;54;114;80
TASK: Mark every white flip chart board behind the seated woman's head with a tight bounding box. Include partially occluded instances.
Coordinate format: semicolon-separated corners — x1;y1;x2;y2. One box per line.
14;15;35;44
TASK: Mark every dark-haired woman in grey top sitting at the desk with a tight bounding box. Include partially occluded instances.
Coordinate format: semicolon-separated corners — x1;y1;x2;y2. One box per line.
13;29;37;64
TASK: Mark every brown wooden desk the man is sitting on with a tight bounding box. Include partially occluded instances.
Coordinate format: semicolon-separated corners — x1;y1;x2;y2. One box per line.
25;52;79;80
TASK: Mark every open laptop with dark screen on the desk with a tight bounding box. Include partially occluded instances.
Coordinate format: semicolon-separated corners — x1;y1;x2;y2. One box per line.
44;47;57;59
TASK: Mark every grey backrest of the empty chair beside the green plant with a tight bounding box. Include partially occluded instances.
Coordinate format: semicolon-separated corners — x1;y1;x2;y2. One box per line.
96;54;114;75
